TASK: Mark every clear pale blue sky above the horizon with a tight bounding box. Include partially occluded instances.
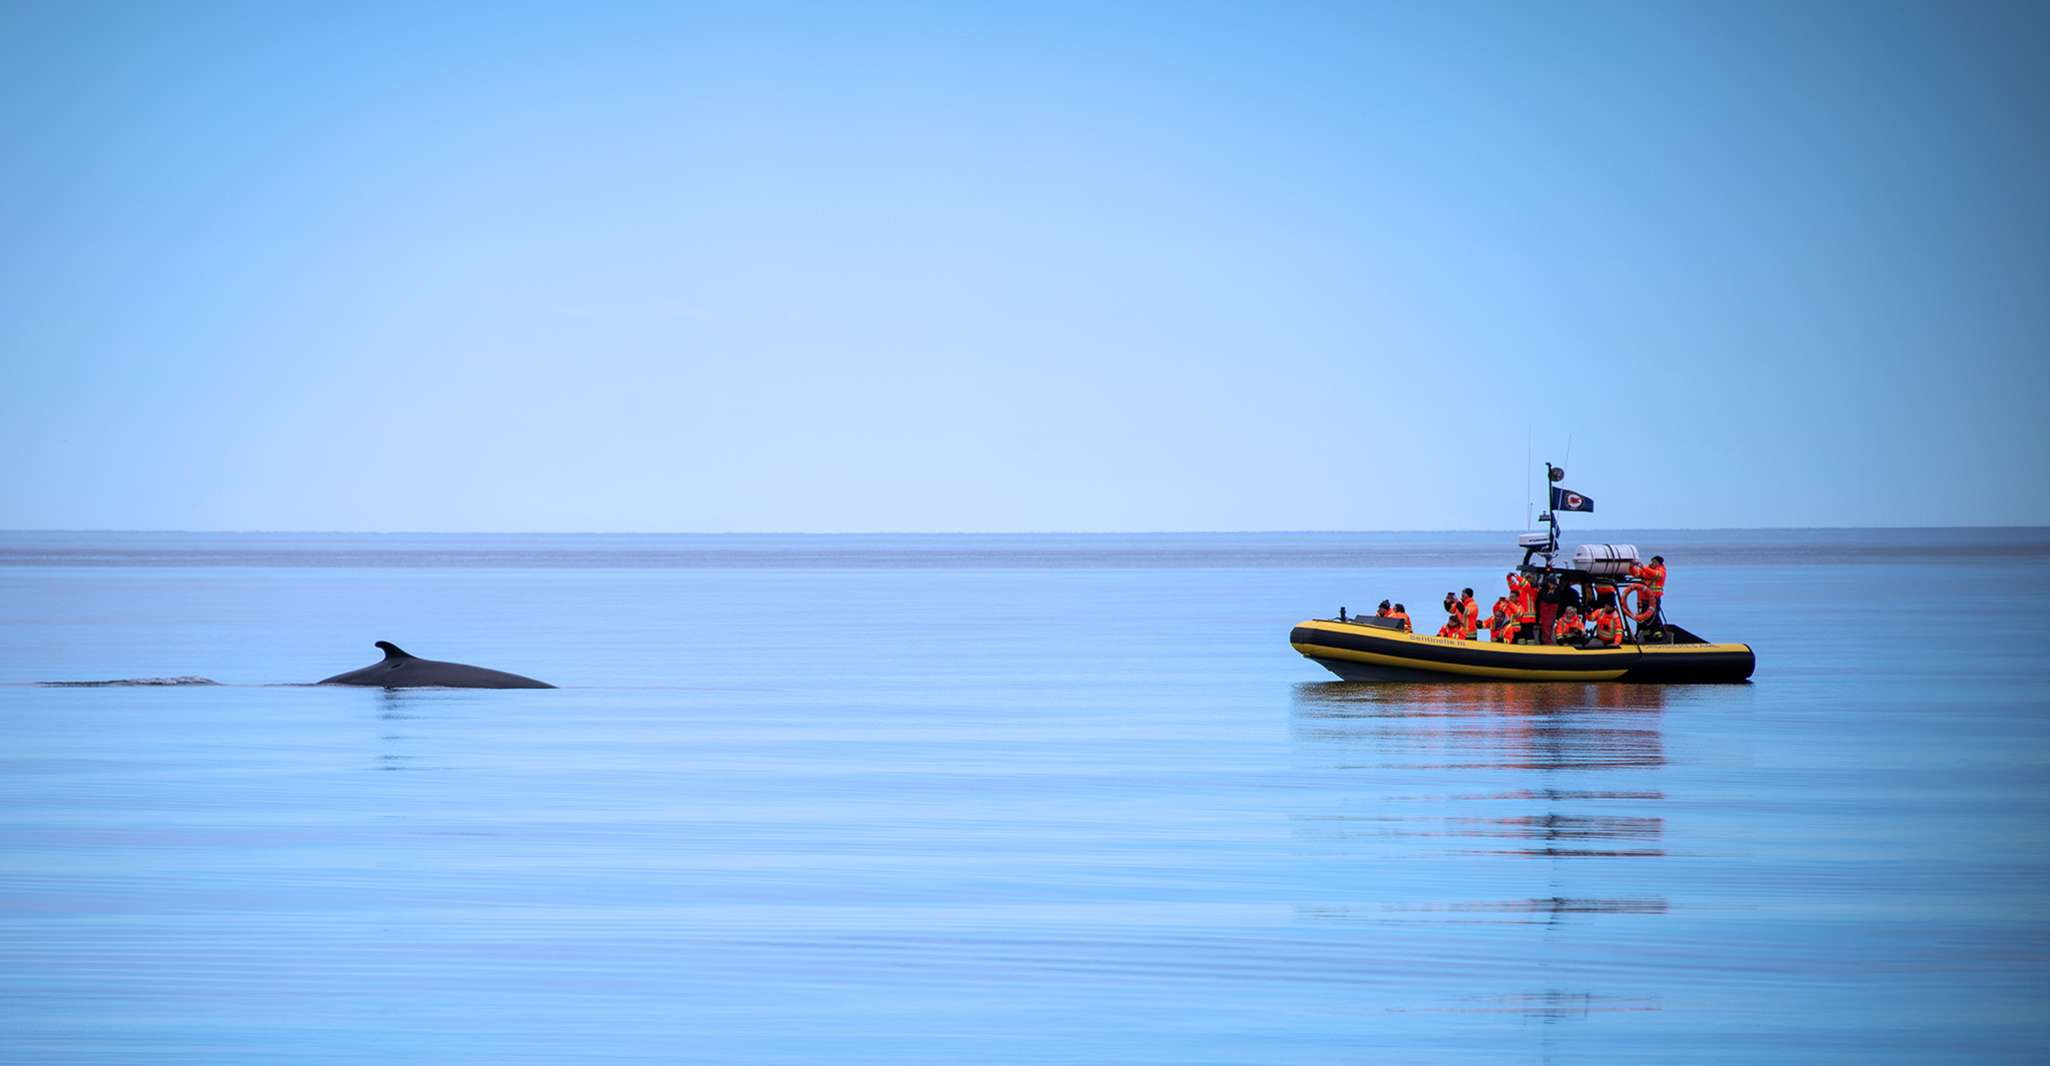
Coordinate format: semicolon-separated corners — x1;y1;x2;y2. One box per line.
0;0;2050;531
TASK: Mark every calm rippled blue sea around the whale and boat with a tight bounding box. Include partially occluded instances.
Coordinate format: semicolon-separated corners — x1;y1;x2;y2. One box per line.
0;529;2050;1064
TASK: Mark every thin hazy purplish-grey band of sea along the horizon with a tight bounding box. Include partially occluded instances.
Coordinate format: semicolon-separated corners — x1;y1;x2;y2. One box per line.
0;529;2050;569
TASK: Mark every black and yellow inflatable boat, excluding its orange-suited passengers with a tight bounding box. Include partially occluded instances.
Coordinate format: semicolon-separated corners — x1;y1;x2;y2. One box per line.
1289;463;1757;685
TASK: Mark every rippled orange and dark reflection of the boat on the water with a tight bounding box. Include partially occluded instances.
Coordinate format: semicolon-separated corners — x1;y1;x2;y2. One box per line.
1292;681;1672;1025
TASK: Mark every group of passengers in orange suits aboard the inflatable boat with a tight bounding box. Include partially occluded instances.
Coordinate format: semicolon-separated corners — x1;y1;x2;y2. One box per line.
1374;556;1665;648
